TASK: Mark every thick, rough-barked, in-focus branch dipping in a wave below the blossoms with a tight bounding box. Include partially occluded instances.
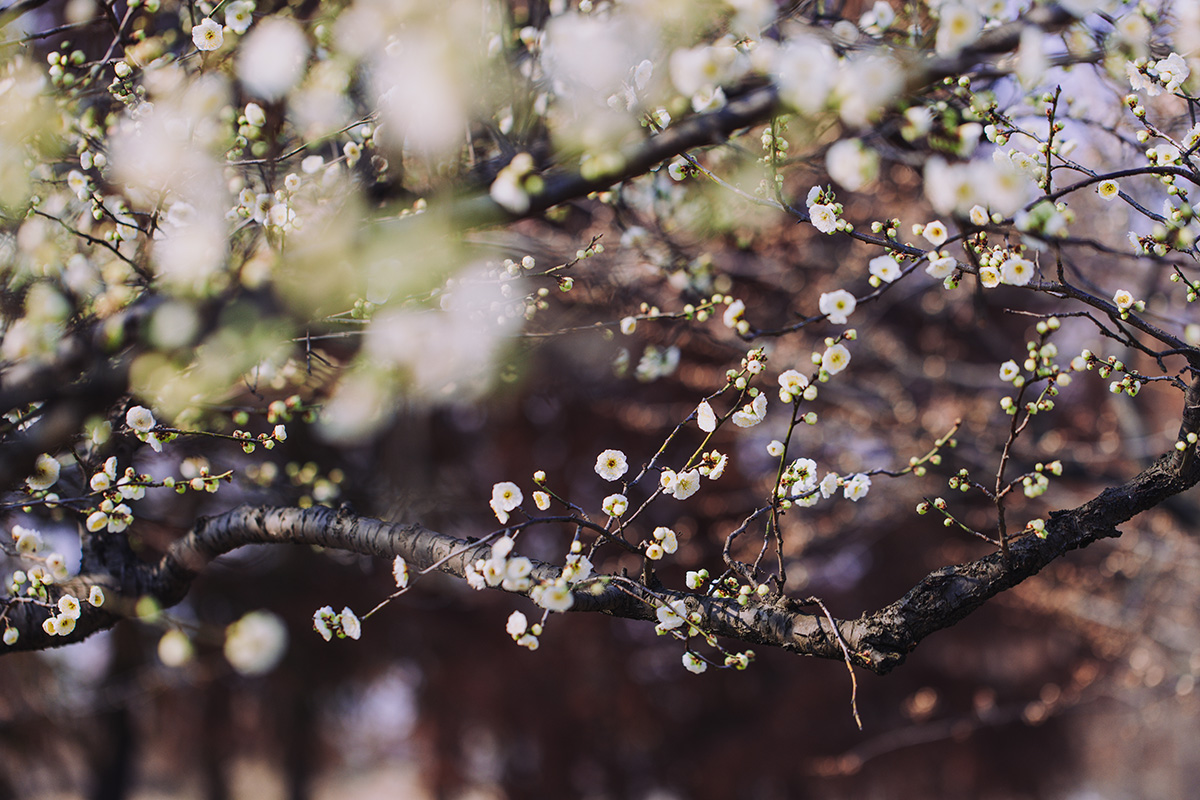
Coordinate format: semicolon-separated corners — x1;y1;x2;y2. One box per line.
7;381;1200;674
